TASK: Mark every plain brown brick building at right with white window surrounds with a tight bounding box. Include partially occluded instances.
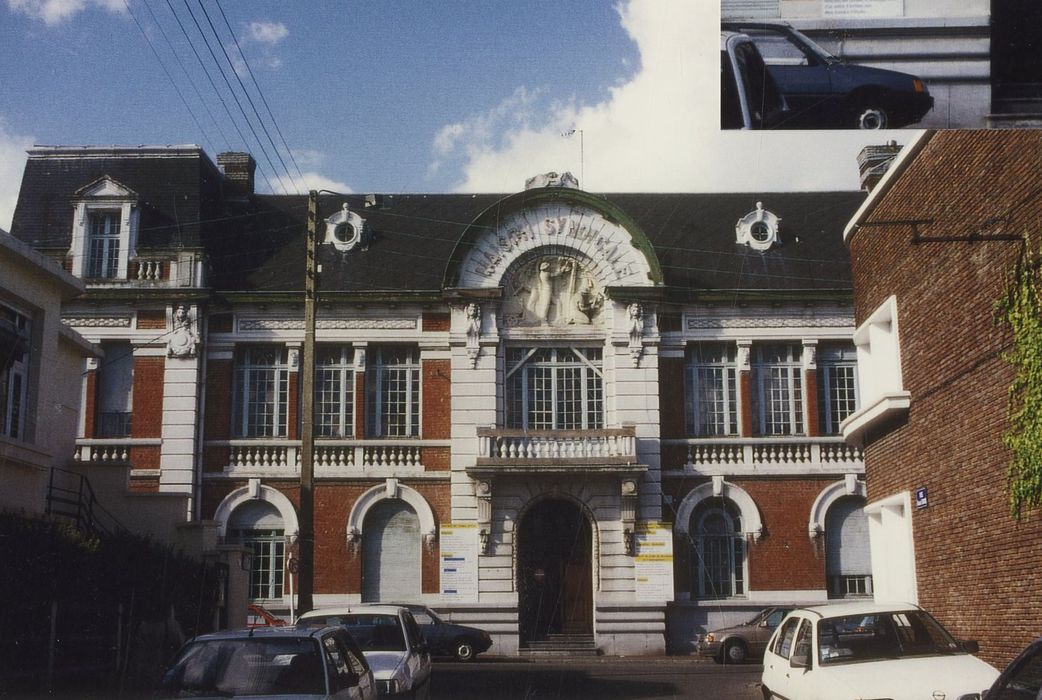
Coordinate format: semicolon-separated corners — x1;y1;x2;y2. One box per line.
843;131;1042;665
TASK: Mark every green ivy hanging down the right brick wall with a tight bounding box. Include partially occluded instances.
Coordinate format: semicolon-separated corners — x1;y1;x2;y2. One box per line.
997;253;1042;519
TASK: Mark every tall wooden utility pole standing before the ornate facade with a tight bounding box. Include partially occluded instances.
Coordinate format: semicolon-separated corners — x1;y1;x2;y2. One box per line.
297;190;319;615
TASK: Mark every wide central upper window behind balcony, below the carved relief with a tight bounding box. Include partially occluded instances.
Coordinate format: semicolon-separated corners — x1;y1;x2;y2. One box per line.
506;348;604;430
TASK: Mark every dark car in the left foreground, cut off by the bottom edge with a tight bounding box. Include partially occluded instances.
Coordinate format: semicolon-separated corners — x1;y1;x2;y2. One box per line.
157;627;377;700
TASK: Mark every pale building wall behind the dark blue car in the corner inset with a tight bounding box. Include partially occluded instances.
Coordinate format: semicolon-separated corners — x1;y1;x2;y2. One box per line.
720;0;1042;128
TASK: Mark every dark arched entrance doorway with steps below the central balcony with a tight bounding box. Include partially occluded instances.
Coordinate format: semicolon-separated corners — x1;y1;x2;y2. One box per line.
517;498;593;644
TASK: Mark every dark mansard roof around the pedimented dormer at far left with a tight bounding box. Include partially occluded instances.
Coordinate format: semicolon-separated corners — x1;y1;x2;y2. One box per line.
11;146;221;249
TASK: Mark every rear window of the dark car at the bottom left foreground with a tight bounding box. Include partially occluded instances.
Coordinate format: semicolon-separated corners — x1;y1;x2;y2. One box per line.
159;638;326;698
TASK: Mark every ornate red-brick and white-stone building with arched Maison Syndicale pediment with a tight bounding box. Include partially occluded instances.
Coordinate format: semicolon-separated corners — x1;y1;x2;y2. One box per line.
13;147;871;654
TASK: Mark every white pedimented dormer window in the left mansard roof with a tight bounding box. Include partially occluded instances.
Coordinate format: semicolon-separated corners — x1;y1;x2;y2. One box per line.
69;176;139;280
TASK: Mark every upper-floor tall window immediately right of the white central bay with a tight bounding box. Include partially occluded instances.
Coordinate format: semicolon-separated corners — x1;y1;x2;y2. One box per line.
685;343;739;435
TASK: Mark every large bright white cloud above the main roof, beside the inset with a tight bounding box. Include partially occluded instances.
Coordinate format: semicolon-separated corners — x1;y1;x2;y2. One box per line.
429;0;912;192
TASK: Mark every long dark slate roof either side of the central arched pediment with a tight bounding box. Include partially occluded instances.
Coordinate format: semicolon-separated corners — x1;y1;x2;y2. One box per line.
209;192;865;293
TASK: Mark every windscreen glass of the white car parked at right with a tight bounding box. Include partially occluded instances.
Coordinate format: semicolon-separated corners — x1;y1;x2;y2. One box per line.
818;610;962;666
